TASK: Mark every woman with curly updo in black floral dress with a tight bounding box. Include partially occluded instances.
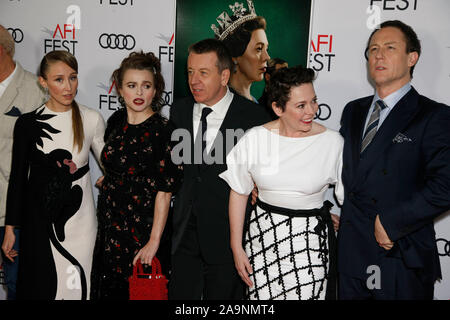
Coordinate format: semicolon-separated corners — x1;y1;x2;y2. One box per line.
91;52;182;300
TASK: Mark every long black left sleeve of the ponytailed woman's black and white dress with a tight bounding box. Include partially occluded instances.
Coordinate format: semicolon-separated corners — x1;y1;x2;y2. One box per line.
5;116;31;226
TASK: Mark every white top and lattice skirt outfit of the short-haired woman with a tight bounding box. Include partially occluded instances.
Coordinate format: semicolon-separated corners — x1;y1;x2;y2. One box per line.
220;126;344;300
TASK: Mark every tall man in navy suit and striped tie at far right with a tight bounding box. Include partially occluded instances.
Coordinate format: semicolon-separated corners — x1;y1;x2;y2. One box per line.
338;20;450;300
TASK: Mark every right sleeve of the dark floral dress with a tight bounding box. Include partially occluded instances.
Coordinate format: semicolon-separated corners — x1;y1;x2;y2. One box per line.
156;122;183;193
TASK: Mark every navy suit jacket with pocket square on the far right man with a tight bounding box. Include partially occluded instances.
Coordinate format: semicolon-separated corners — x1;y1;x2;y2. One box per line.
338;88;450;281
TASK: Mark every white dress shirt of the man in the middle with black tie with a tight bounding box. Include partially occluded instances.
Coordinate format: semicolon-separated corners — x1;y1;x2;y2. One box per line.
192;87;234;152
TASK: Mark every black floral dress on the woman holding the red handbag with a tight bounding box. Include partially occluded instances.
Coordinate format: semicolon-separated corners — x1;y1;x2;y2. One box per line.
91;109;182;299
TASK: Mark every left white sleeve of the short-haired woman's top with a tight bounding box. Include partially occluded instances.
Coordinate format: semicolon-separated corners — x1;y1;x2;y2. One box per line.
219;134;254;195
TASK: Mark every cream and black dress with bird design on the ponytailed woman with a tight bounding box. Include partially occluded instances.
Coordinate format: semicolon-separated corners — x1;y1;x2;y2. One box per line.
6;105;105;300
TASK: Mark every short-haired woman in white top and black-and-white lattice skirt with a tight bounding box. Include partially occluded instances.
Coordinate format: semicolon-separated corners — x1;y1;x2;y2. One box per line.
220;67;343;300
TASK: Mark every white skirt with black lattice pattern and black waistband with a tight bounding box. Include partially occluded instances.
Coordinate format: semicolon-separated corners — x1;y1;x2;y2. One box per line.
244;199;335;300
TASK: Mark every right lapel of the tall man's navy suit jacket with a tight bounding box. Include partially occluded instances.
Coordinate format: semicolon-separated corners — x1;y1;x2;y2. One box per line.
357;88;420;186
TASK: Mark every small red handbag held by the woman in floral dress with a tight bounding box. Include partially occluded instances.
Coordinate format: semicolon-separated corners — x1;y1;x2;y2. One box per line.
128;257;168;300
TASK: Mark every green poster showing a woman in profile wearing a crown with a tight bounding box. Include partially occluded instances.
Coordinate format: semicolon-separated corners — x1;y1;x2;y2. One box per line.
174;0;312;102
